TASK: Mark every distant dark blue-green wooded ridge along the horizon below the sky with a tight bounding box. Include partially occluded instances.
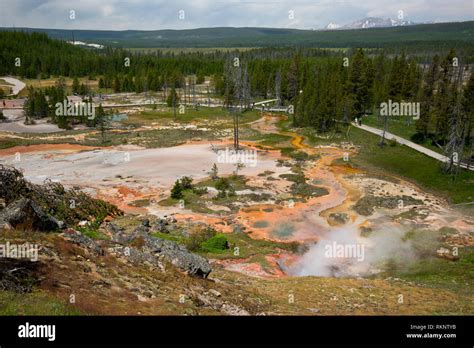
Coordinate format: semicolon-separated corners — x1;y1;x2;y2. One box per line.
0;21;474;48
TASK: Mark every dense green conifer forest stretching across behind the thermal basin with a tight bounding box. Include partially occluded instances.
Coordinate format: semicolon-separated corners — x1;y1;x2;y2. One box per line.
0;32;474;159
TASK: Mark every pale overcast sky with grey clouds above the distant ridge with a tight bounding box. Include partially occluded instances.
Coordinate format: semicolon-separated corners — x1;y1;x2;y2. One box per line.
0;0;474;30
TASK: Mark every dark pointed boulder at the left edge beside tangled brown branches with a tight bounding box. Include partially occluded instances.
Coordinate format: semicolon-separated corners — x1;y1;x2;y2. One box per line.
0;198;65;232
